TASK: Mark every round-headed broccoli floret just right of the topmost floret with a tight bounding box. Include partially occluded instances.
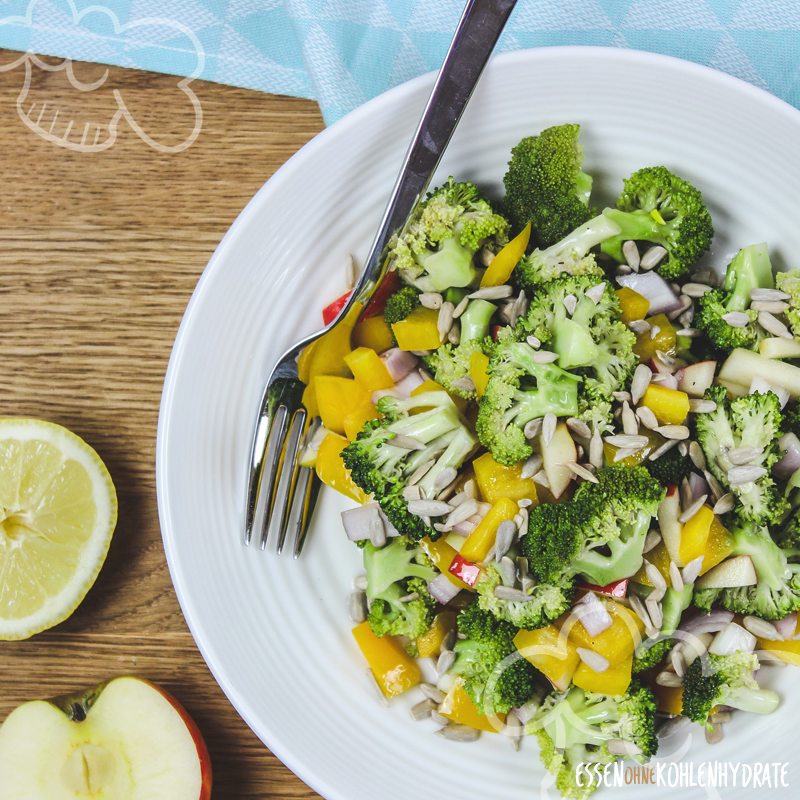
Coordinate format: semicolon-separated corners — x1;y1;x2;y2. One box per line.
601;167;714;280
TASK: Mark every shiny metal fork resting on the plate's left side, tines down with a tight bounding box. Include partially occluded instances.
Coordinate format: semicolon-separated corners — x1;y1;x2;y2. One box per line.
244;0;516;558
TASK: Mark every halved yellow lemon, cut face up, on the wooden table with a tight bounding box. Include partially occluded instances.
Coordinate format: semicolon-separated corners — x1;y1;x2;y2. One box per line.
0;419;117;639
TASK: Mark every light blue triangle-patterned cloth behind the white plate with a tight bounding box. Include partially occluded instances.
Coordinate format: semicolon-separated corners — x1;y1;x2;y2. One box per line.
0;0;800;123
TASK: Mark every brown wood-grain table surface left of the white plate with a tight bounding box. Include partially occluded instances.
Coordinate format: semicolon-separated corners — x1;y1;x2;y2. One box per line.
0;51;323;800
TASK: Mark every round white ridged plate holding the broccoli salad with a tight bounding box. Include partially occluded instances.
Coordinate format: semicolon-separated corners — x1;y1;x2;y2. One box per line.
156;48;800;800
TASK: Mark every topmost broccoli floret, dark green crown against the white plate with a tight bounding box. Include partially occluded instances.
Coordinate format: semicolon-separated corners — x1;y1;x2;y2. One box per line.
503;125;593;247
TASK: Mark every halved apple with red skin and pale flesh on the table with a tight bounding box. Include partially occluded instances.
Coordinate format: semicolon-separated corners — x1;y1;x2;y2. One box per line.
0;677;211;800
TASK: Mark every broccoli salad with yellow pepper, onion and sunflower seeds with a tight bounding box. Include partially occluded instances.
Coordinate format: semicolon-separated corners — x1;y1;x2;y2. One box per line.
298;124;800;797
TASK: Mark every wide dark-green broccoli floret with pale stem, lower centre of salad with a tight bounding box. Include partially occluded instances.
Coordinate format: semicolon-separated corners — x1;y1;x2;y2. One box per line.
522;465;666;586
